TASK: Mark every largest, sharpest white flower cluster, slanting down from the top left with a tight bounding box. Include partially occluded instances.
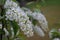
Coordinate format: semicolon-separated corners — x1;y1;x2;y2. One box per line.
4;0;33;37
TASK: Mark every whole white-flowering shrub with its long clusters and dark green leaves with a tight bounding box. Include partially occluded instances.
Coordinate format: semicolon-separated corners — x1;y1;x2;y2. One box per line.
0;0;48;40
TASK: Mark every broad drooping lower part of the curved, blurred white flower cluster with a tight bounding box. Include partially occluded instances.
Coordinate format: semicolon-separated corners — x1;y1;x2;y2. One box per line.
32;12;48;31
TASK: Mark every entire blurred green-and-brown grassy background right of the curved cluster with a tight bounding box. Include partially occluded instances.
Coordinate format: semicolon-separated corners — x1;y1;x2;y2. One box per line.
41;0;60;28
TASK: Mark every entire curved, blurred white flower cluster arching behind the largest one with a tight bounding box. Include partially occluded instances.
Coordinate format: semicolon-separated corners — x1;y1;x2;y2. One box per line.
23;8;48;32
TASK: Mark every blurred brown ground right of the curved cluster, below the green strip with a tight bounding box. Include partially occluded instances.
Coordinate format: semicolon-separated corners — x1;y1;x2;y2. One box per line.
41;5;60;29
